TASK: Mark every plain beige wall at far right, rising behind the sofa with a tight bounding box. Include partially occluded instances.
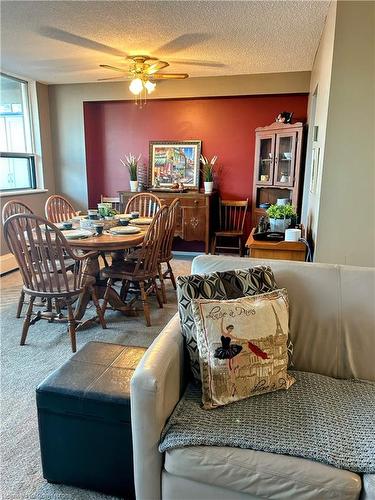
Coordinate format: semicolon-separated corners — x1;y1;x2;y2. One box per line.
315;1;375;266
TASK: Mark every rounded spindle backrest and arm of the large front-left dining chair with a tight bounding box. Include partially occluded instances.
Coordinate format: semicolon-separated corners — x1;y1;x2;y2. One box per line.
4;214;86;296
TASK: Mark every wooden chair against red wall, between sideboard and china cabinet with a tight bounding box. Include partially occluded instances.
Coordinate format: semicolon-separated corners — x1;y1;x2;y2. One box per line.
212;199;249;257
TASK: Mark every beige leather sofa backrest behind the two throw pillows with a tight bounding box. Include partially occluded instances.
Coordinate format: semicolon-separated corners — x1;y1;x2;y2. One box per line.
192;256;375;381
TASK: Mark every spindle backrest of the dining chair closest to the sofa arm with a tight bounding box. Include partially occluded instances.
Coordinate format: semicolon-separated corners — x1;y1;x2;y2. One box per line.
134;207;168;274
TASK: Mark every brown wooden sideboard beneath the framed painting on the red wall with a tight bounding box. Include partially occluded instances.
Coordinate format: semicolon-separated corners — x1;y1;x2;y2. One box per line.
118;191;216;253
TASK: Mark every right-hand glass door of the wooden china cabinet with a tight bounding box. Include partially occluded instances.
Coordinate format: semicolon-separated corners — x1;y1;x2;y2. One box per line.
274;132;296;186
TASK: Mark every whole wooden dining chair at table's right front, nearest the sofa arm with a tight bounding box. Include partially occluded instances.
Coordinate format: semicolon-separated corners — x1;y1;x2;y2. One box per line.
101;207;168;326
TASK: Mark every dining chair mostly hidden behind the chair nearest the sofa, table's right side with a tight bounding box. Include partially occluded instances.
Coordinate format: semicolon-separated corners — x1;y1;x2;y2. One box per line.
158;198;180;304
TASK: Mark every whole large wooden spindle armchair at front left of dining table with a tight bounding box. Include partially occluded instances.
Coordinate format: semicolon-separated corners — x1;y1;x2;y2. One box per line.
4;214;106;352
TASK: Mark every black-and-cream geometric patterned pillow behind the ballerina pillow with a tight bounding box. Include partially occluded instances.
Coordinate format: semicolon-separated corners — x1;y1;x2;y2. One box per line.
177;266;278;382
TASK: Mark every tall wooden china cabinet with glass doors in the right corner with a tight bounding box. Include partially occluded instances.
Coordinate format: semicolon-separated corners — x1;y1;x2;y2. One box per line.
252;122;303;227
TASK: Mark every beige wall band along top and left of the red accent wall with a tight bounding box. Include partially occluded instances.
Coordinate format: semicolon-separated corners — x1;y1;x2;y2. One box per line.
49;72;310;209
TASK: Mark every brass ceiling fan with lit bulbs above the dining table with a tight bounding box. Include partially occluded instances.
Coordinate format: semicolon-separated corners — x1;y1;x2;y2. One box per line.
99;55;189;96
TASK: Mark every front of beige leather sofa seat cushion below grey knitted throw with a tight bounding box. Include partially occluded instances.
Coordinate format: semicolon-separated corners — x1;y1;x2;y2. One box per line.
164;446;361;500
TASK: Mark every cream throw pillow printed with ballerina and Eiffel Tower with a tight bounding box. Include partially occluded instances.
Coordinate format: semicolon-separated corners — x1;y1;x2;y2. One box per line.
192;289;295;409
